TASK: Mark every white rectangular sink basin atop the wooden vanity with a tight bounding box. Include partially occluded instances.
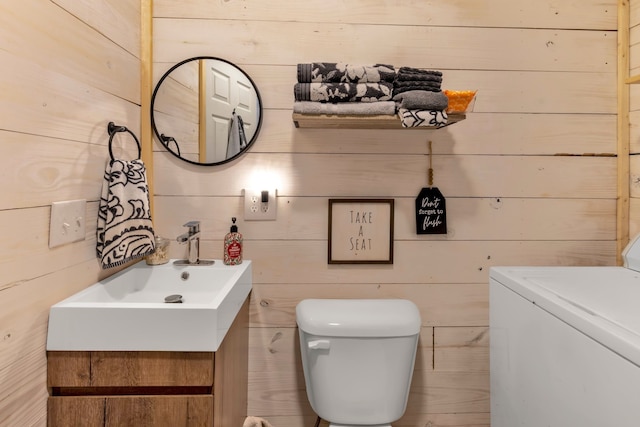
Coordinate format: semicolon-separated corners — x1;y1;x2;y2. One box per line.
47;260;252;351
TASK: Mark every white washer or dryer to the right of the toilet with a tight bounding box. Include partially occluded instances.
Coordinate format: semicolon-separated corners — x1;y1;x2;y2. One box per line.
489;238;640;427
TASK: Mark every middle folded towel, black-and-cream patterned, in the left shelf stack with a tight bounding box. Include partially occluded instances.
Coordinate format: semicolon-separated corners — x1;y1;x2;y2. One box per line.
293;82;393;102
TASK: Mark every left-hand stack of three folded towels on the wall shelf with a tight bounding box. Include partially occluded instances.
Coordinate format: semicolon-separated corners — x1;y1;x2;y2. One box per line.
293;62;396;115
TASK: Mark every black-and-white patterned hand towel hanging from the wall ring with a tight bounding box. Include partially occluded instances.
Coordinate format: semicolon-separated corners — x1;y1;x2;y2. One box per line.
96;160;155;268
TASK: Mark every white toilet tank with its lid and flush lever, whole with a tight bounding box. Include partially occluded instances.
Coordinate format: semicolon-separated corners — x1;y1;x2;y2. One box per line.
296;299;421;427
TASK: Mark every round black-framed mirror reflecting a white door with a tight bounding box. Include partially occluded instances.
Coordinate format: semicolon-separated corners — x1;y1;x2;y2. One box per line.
151;56;262;165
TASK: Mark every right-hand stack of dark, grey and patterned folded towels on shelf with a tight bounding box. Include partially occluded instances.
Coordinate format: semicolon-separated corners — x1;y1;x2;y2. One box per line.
393;67;449;127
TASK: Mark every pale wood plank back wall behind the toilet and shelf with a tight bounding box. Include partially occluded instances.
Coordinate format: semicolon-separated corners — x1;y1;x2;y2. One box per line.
153;0;616;427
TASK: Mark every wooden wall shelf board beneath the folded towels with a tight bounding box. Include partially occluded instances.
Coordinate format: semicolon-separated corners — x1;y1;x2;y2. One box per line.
293;113;467;130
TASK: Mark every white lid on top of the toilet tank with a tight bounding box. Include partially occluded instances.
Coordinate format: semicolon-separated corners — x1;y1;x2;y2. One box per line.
296;299;421;337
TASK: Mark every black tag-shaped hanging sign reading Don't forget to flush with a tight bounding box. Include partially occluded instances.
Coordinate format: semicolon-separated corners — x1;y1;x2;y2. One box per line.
416;141;447;234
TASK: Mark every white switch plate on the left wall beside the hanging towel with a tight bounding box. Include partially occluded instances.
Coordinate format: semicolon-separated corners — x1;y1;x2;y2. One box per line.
49;199;87;248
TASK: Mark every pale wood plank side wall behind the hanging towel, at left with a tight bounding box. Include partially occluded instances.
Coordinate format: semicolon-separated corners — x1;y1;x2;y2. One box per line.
0;0;140;426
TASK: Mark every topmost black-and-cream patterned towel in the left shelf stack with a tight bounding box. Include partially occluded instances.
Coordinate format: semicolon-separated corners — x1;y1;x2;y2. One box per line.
298;62;396;83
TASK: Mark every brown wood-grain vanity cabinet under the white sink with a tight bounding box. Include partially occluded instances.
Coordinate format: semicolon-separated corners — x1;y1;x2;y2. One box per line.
47;298;249;427
